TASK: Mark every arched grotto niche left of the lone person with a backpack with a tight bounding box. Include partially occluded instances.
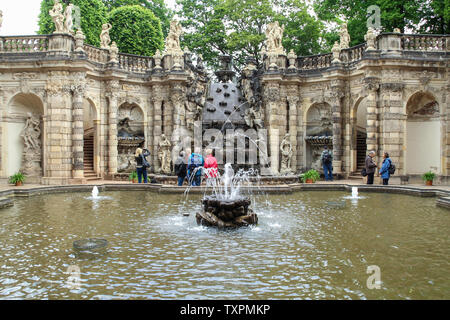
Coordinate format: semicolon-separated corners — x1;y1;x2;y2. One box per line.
303;102;333;172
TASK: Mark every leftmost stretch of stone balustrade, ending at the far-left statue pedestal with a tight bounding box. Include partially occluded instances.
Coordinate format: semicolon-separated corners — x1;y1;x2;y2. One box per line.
0;35;49;53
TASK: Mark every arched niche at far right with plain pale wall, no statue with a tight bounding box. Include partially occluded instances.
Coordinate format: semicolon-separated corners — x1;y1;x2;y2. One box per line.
404;91;442;175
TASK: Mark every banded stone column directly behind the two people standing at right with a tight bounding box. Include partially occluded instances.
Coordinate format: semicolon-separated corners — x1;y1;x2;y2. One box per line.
364;77;379;154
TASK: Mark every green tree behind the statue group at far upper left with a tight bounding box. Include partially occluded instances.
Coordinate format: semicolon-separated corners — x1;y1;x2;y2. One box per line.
38;0;107;46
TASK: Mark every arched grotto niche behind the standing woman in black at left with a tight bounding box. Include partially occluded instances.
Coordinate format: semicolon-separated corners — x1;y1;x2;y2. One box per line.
117;102;146;173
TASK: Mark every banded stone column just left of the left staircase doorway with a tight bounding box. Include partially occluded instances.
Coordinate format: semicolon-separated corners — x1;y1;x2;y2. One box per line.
72;83;86;179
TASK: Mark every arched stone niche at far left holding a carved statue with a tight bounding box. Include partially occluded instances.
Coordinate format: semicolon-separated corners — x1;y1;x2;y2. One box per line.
1;93;45;183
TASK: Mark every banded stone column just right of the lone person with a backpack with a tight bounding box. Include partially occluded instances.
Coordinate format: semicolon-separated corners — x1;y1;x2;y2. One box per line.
330;83;344;173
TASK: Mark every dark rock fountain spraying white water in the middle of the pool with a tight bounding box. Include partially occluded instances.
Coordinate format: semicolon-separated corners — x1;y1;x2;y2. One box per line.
196;163;258;228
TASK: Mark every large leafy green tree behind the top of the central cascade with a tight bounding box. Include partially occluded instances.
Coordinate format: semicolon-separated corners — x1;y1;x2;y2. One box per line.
177;0;322;68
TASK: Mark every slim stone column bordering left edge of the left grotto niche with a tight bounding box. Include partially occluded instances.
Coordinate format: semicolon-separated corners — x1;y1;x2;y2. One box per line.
108;80;119;176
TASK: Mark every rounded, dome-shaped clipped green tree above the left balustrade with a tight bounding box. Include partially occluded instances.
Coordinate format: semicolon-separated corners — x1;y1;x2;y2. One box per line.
108;5;164;56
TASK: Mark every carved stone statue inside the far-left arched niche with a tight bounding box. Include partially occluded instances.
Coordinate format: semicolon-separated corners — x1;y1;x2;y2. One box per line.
21;113;42;176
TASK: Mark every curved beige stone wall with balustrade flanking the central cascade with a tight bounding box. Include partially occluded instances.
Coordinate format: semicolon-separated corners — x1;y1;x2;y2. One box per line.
0;33;450;184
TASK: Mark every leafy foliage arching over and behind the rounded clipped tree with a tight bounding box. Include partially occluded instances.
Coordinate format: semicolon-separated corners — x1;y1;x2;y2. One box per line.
102;0;173;37
